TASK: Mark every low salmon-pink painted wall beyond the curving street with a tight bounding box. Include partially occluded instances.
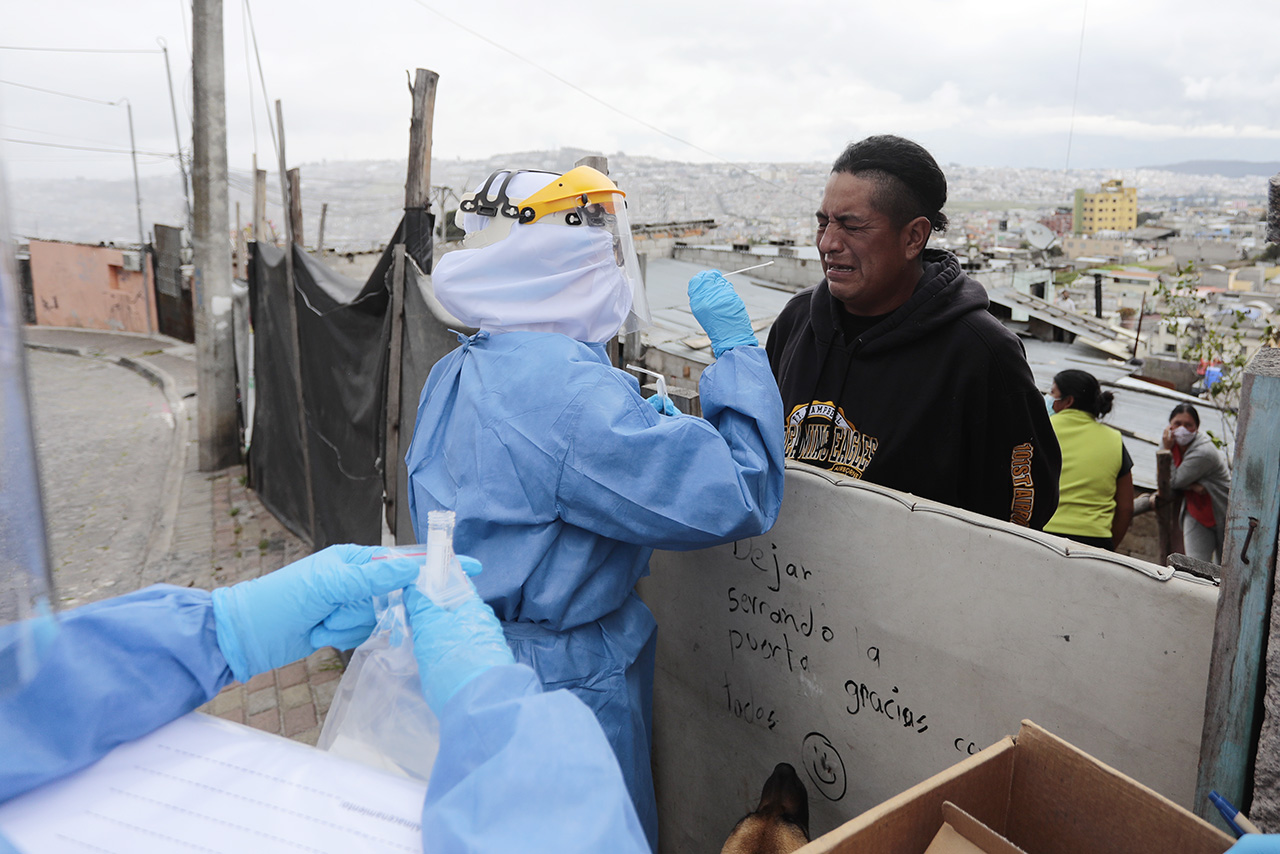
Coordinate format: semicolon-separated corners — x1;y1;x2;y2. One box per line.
31;241;157;332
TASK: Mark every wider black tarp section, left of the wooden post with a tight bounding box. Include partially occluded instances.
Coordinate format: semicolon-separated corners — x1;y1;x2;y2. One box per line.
248;229;399;549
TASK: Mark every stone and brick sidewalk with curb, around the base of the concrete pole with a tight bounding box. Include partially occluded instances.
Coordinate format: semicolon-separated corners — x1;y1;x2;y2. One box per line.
23;326;343;744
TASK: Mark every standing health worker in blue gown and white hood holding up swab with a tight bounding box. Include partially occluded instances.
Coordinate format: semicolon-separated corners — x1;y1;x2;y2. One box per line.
406;166;783;842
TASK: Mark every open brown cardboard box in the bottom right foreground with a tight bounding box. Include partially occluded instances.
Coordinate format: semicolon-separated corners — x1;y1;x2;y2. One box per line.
797;721;1235;854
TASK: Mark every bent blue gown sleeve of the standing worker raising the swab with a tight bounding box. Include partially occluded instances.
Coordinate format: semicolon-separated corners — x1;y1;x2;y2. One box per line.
556;346;786;549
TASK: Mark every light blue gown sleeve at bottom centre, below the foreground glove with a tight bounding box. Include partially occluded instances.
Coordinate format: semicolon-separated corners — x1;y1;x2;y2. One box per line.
422;665;649;854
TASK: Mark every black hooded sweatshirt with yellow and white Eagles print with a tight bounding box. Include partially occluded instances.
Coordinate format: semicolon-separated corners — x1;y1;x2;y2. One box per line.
767;248;1062;529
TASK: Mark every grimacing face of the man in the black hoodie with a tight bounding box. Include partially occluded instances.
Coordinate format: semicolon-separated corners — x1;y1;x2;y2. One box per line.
818;172;928;316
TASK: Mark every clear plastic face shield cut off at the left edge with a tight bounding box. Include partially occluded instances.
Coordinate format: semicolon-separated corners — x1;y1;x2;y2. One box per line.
0;148;58;697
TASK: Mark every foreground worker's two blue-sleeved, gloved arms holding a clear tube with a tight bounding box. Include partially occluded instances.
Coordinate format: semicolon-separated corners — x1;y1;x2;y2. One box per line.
0;545;648;854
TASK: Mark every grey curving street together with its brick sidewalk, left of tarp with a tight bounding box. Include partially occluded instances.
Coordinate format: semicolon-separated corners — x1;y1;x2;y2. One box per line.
24;326;330;744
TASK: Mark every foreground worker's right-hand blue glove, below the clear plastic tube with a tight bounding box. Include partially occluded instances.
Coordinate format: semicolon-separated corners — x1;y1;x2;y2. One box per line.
404;586;516;716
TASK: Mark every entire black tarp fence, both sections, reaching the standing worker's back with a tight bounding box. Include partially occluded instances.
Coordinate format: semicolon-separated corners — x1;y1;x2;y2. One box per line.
241;211;475;548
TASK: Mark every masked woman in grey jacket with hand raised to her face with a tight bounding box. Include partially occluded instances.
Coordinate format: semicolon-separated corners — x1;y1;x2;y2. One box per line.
1165;403;1231;562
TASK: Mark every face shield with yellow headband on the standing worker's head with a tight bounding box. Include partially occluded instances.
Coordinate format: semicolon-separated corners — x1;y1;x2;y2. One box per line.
454;166;652;334
